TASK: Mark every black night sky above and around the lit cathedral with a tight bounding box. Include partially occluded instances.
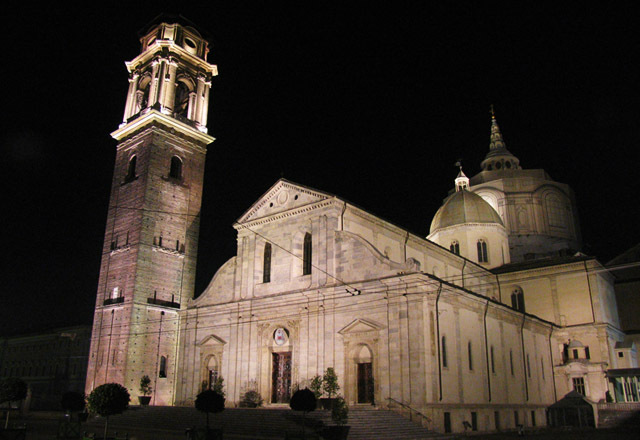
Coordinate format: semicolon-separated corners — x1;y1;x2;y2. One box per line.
0;1;640;335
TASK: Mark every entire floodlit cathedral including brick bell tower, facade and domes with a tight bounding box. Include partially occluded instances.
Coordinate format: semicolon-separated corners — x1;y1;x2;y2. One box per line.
86;18;638;432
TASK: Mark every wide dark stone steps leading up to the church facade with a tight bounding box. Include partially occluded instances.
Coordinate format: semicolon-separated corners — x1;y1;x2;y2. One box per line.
80;406;452;440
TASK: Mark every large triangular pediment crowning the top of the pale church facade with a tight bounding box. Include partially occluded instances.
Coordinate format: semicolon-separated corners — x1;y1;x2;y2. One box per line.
238;179;334;224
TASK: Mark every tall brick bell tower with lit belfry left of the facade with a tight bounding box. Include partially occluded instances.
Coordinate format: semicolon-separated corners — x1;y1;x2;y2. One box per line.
86;17;217;405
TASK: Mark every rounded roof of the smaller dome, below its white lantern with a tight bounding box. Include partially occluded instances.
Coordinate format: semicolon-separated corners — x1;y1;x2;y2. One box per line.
429;190;504;234
